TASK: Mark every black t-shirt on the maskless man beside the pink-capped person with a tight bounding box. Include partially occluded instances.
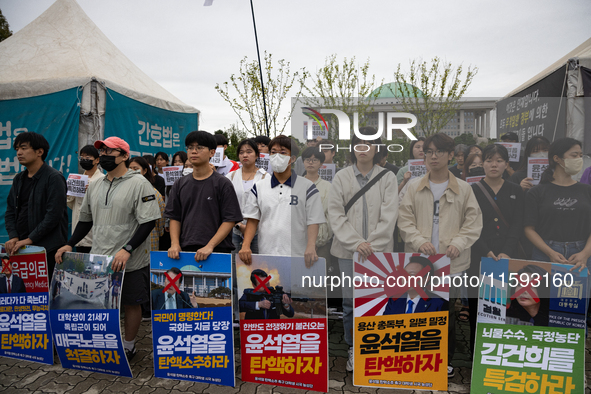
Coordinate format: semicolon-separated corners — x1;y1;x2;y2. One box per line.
164;171;242;252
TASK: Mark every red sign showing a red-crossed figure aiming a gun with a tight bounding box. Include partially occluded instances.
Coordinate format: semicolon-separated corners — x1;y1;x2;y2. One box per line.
236;255;328;392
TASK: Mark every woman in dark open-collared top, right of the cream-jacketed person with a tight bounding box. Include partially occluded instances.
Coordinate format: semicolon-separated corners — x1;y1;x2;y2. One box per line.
468;144;525;353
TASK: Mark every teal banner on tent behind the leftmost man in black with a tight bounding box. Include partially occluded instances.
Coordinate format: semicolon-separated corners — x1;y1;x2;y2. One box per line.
0;88;80;242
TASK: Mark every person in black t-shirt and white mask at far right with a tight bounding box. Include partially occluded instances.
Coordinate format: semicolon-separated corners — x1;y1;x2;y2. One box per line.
524;138;591;272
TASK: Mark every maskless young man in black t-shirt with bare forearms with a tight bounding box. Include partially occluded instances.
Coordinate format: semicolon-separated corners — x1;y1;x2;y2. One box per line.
164;131;242;261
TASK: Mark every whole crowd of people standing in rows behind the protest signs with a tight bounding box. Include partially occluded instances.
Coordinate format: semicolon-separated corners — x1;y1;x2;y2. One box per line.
5;127;591;377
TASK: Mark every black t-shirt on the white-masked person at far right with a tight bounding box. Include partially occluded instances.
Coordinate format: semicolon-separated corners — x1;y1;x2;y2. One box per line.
524;182;591;242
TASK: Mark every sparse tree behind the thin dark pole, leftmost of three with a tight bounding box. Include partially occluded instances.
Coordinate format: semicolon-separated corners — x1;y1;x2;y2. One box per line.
215;52;307;136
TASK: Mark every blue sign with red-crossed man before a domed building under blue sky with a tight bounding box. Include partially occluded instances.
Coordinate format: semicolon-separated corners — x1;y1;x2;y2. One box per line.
150;252;235;387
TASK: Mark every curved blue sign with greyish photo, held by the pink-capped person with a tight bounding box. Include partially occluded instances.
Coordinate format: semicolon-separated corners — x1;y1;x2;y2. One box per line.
49;252;132;378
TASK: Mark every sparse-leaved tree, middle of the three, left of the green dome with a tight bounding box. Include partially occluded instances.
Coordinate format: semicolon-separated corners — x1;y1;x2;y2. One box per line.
302;54;383;140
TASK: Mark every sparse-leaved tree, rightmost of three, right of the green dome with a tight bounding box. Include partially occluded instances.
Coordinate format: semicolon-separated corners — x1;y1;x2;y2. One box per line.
394;57;478;136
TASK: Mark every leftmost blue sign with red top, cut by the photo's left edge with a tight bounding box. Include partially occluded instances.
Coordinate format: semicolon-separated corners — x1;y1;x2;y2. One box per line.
0;246;53;365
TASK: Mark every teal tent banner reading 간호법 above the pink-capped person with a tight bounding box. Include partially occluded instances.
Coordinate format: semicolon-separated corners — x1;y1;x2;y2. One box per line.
105;90;198;157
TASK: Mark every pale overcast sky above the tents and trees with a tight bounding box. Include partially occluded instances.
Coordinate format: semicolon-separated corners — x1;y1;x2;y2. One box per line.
0;0;591;138
